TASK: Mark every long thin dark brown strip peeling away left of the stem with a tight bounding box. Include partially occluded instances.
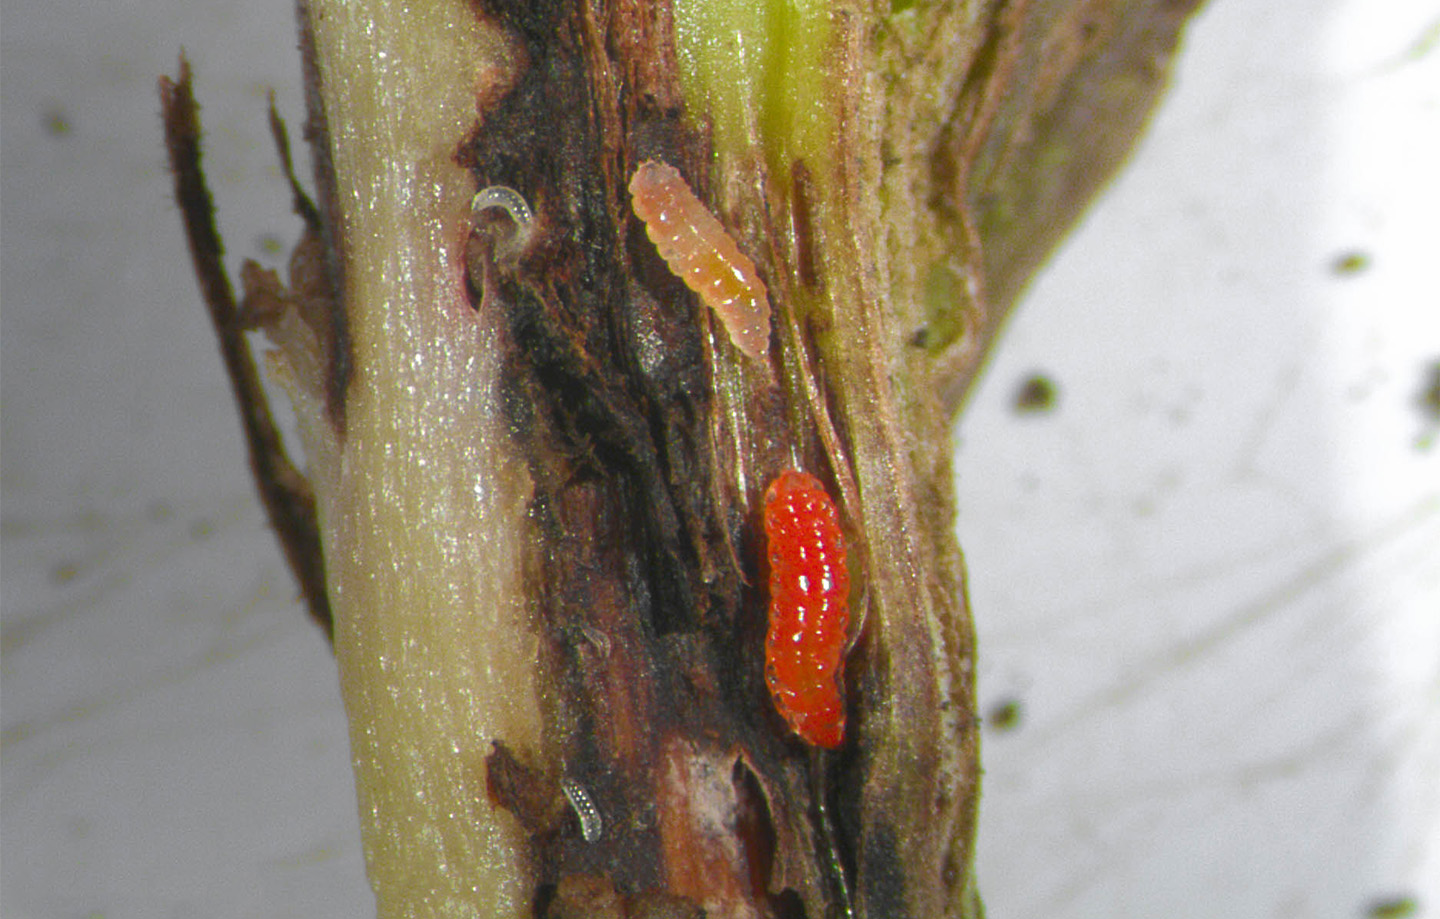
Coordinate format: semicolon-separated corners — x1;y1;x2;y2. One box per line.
160;56;333;638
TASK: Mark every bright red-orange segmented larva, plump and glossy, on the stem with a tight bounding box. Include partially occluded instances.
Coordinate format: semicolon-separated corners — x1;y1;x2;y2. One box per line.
763;470;850;748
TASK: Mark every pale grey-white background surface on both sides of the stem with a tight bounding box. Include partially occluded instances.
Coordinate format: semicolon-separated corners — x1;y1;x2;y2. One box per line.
0;0;1440;919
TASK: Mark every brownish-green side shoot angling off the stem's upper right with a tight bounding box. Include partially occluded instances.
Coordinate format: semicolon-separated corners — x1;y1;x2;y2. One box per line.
915;0;1202;412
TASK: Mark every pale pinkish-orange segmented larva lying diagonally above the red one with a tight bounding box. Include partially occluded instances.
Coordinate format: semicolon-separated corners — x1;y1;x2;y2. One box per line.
629;160;770;360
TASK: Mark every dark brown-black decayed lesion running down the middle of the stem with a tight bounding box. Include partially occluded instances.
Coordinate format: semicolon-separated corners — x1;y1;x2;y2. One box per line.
462;4;825;916
